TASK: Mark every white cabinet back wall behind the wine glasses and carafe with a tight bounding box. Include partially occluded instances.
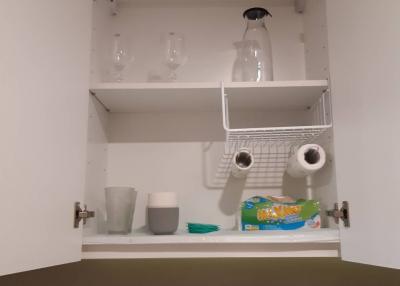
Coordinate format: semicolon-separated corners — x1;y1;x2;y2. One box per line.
94;2;305;82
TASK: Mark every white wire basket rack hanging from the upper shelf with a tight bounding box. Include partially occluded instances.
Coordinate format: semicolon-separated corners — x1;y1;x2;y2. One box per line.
213;83;332;188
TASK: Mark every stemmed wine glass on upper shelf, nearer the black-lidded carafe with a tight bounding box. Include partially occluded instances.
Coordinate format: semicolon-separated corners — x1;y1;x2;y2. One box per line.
164;32;187;81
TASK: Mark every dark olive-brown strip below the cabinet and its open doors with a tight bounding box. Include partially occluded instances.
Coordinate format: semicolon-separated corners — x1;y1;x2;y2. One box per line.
0;258;400;286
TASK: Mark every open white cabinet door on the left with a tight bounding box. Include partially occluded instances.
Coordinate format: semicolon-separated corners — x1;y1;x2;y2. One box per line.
0;0;91;275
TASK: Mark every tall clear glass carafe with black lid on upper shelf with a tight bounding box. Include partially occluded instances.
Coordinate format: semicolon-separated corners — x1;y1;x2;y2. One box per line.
243;7;273;81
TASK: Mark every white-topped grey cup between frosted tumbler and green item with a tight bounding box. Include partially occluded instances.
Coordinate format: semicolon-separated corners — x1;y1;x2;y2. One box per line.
147;192;179;234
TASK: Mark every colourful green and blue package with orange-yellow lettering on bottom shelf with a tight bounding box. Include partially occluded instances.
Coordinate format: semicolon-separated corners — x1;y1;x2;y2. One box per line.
241;196;321;231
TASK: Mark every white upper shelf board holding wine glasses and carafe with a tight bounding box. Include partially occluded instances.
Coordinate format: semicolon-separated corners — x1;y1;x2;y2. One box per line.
90;80;328;112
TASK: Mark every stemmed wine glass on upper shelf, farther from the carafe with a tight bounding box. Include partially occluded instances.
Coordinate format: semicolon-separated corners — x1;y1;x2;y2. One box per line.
112;33;133;82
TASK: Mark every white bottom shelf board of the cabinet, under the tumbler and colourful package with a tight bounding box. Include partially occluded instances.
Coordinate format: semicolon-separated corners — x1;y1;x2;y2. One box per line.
83;229;339;259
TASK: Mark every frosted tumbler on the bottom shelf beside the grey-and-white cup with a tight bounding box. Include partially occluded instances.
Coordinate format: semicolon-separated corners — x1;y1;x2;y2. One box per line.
105;187;137;234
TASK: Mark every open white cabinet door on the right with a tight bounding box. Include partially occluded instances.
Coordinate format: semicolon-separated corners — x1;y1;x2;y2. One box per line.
327;0;400;268
